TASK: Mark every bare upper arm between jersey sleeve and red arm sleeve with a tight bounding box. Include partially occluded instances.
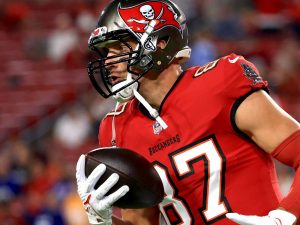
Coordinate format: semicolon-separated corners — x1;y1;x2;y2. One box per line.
235;90;300;152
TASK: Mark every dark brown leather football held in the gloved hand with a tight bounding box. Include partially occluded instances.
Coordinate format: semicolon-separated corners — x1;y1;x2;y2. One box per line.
85;148;164;209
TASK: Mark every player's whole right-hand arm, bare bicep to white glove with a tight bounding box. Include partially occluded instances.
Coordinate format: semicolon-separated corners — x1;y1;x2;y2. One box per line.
228;90;300;225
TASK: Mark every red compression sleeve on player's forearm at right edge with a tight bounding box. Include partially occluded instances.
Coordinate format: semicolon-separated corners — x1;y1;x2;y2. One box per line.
272;130;300;217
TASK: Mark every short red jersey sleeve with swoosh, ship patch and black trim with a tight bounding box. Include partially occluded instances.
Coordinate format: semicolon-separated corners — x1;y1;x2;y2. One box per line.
218;54;268;136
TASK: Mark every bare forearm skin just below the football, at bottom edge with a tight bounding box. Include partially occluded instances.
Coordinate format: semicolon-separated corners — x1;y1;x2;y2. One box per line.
122;207;159;225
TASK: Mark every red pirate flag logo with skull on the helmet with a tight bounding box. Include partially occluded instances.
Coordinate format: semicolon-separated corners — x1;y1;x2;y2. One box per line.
119;1;181;33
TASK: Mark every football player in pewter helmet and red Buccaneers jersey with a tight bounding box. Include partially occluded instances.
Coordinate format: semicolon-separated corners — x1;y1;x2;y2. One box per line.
76;0;300;225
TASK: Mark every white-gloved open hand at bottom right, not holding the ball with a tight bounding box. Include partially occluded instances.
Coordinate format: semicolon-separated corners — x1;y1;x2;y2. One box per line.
226;209;296;225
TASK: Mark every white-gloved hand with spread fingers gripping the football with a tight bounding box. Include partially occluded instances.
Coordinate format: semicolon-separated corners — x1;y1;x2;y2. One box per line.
76;155;129;225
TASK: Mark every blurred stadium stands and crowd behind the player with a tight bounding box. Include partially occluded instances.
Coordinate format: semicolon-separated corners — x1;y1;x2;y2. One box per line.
0;0;300;225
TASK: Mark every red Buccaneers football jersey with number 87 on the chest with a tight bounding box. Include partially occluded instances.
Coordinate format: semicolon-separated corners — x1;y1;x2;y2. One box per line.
99;54;281;225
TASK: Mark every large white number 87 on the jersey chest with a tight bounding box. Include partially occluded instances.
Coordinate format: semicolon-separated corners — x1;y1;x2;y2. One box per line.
154;137;230;225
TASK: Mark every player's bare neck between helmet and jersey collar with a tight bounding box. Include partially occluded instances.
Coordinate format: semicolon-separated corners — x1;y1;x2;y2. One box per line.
139;64;182;109
